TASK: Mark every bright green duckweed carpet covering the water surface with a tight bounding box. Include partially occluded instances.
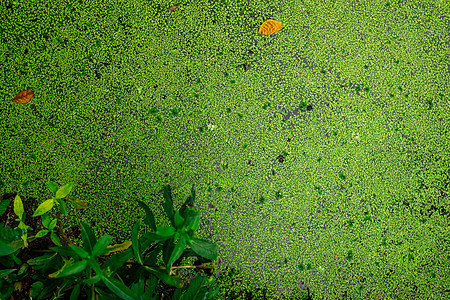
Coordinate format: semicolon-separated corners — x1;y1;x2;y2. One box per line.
0;0;450;299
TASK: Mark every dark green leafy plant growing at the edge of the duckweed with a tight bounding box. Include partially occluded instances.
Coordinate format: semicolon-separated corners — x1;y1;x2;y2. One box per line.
0;185;219;299
